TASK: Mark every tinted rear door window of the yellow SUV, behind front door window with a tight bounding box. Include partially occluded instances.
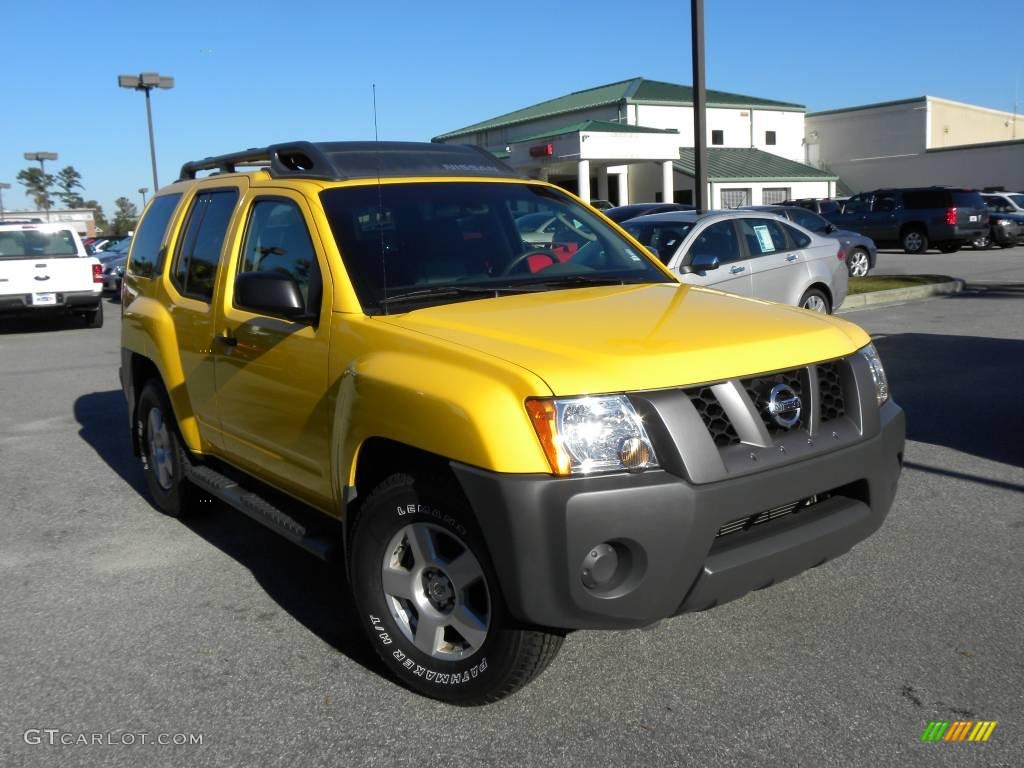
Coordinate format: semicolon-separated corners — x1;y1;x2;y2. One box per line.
171;189;239;302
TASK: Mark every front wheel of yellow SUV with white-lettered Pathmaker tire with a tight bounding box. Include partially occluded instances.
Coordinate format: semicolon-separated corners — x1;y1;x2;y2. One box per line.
350;474;564;706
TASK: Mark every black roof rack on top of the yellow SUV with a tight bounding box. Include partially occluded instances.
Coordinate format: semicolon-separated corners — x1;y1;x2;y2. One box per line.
178;141;521;181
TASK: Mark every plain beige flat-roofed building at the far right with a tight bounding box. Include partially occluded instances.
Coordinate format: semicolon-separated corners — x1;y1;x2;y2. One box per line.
804;96;1024;193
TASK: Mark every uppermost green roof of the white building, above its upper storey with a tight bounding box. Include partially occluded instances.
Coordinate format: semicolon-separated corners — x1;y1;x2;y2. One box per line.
433;78;804;141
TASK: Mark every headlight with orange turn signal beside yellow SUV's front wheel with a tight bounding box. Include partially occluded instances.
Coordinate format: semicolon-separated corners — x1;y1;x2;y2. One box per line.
526;395;657;475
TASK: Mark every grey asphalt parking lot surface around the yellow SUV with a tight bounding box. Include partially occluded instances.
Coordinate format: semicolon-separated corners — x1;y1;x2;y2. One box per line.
0;248;1024;767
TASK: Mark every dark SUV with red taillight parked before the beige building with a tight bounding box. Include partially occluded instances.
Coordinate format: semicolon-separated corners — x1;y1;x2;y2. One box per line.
824;186;988;253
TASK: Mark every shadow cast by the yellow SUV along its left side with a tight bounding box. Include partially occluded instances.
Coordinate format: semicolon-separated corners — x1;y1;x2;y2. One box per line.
74;389;390;679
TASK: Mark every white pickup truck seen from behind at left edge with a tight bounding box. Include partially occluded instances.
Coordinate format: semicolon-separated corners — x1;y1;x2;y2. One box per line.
0;221;103;328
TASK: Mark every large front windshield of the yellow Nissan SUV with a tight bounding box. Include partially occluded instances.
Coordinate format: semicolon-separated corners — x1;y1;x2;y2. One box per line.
321;181;672;314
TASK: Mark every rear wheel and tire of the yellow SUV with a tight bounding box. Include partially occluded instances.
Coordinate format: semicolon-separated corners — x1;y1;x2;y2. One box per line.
135;379;208;517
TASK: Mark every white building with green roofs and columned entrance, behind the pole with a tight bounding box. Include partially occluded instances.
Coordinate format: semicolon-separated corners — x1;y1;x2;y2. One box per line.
433;78;837;206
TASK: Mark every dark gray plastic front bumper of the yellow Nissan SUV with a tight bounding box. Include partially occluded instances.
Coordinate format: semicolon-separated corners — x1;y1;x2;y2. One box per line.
453;401;905;629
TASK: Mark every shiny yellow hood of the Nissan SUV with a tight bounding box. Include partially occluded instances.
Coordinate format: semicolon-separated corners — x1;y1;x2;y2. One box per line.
379;284;870;395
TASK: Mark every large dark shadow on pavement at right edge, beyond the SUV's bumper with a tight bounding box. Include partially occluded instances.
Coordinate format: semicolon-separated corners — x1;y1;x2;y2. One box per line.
874;334;1024;467
